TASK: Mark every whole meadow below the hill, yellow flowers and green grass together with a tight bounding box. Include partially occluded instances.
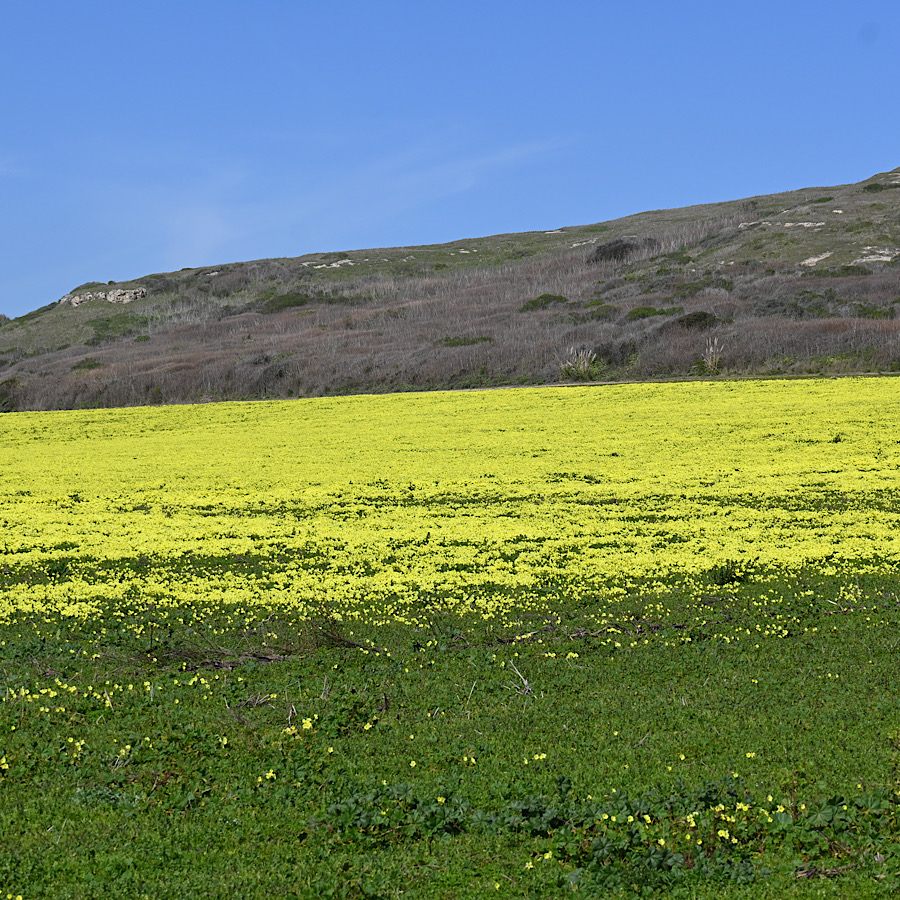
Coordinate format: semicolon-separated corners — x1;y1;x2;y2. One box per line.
0;378;900;900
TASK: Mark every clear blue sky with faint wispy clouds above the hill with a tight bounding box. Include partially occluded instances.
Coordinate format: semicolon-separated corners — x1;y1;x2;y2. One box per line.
0;0;900;316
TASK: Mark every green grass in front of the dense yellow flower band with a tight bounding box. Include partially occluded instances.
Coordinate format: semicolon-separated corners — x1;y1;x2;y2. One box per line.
0;558;900;898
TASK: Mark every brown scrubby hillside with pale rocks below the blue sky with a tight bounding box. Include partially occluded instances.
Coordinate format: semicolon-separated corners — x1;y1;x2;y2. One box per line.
0;168;900;410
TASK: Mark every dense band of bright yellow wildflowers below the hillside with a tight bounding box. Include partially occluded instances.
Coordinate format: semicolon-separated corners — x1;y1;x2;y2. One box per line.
0;378;900;632
